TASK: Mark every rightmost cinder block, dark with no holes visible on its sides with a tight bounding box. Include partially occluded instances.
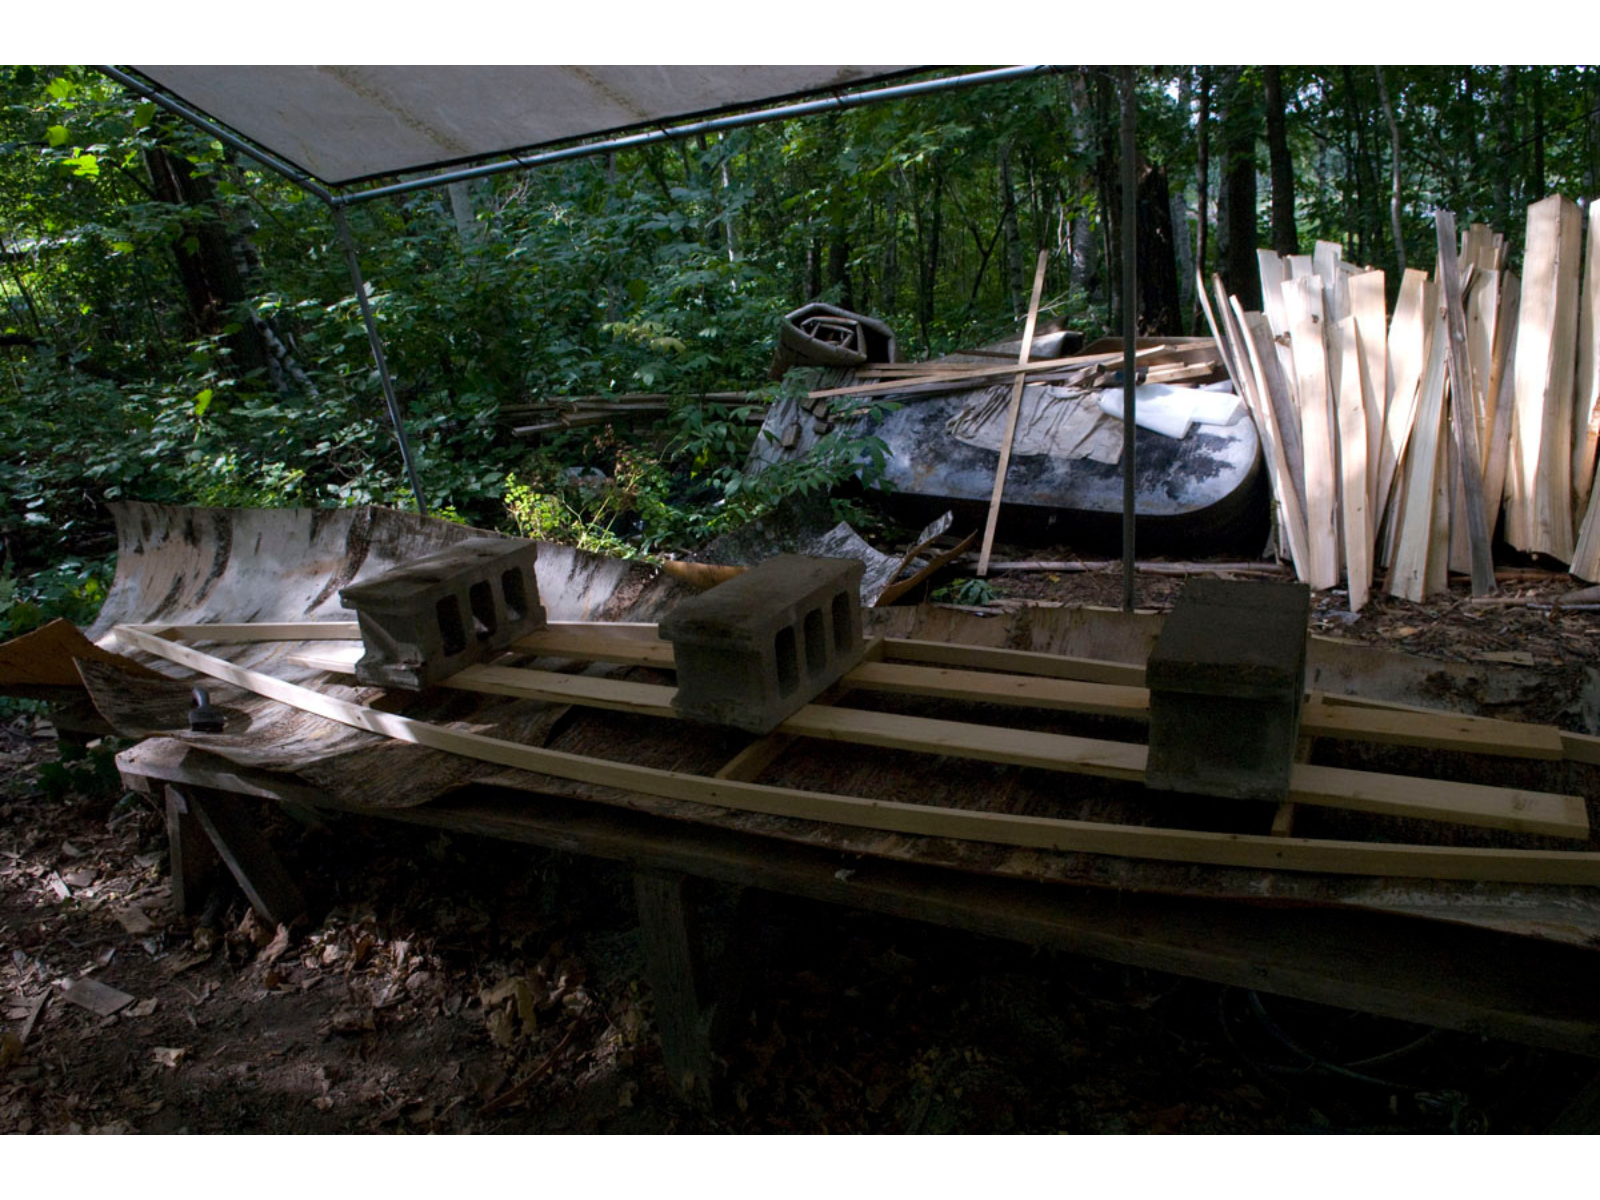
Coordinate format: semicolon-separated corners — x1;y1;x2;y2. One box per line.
1144;579;1310;800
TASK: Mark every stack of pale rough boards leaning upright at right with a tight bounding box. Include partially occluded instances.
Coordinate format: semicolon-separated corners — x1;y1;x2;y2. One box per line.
1206;195;1600;611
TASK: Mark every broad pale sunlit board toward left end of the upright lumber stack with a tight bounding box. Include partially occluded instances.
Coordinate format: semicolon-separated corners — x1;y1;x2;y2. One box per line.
1283;276;1339;590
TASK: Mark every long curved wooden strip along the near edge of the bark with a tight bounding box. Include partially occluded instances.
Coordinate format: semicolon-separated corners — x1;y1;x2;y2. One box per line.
123;627;1600;885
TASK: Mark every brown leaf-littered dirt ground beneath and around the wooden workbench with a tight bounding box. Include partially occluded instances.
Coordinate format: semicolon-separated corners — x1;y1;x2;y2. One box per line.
0;573;1600;1133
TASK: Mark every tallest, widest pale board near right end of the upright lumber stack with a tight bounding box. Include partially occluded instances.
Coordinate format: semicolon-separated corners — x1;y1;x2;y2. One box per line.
1509;195;1582;563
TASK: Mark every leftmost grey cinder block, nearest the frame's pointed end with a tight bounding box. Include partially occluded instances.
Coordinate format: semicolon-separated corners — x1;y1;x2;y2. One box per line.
339;538;544;691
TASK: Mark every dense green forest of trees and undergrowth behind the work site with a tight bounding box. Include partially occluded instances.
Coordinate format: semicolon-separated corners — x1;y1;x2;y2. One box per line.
0;66;1600;637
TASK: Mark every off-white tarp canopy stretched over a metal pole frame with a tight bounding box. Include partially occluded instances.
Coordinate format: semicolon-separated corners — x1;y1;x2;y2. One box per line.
134;66;906;186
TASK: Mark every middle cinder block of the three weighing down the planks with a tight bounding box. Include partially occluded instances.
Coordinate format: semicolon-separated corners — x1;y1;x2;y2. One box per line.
661;554;866;733
